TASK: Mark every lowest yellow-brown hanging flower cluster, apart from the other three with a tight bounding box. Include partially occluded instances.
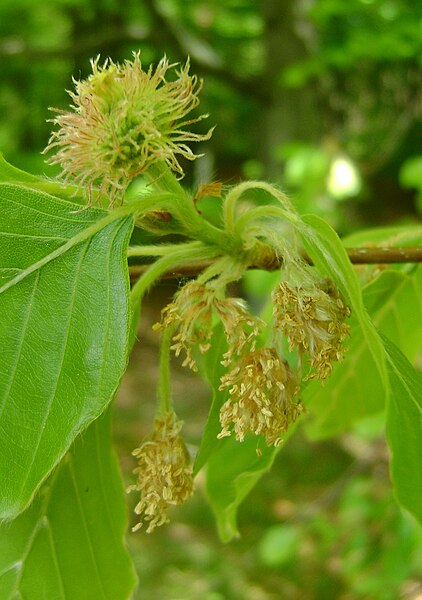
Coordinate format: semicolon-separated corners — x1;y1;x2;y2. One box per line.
127;412;193;533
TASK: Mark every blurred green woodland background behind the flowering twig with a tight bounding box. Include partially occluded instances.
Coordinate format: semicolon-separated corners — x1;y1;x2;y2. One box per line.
0;0;422;600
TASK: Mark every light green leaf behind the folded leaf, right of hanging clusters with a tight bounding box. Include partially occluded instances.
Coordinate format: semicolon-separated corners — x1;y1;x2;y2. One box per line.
304;266;422;439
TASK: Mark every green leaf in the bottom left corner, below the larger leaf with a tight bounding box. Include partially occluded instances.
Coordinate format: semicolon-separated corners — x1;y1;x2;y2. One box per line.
0;411;136;600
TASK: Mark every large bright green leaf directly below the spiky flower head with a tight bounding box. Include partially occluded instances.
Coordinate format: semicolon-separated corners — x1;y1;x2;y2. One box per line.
0;183;133;518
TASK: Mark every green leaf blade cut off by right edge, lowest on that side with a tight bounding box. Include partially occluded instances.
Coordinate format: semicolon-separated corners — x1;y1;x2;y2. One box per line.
384;338;422;525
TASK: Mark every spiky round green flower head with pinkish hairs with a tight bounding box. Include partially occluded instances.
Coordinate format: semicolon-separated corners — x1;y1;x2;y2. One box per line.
45;52;212;205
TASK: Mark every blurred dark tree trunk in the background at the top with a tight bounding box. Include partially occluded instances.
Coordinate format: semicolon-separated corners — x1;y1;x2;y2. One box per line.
261;0;323;180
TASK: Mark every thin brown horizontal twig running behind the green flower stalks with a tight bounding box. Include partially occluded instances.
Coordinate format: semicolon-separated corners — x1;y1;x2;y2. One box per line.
130;246;422;281
